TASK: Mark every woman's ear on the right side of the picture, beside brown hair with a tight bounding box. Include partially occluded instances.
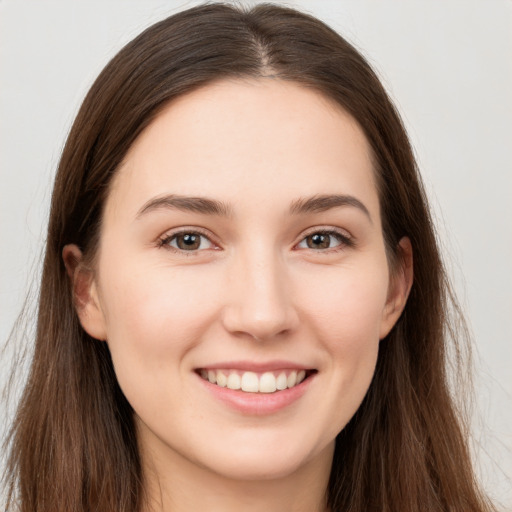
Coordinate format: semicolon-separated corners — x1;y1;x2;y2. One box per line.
380;237;413;339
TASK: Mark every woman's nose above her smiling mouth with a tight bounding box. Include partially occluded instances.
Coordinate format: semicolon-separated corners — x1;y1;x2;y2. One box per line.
222;250;299;341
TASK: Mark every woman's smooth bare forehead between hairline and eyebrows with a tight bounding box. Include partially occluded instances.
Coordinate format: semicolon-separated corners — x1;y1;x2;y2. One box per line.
107;78;378;219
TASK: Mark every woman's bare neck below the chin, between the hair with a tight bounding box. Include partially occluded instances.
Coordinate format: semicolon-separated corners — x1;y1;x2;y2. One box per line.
142;438;334;512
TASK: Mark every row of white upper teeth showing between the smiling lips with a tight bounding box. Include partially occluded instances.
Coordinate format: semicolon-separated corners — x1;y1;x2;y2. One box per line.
197;368;316;393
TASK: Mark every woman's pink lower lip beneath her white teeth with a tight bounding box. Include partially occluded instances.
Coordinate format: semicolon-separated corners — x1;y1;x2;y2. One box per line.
197;374;316;416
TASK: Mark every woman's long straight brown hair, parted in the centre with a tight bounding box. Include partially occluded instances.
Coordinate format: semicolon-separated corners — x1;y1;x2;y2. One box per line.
2;4;492;512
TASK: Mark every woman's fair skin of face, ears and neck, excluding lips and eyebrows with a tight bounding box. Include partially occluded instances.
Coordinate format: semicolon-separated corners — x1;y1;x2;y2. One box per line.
63;78;412;512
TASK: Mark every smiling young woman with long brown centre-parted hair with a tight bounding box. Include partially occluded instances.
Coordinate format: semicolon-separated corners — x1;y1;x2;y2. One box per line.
0;5;492;511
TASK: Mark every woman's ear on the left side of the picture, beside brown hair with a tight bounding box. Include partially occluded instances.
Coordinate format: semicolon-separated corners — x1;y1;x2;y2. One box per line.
62;244;107;340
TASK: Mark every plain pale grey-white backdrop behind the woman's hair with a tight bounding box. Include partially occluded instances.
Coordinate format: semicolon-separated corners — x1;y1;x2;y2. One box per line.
0;0;512;510
